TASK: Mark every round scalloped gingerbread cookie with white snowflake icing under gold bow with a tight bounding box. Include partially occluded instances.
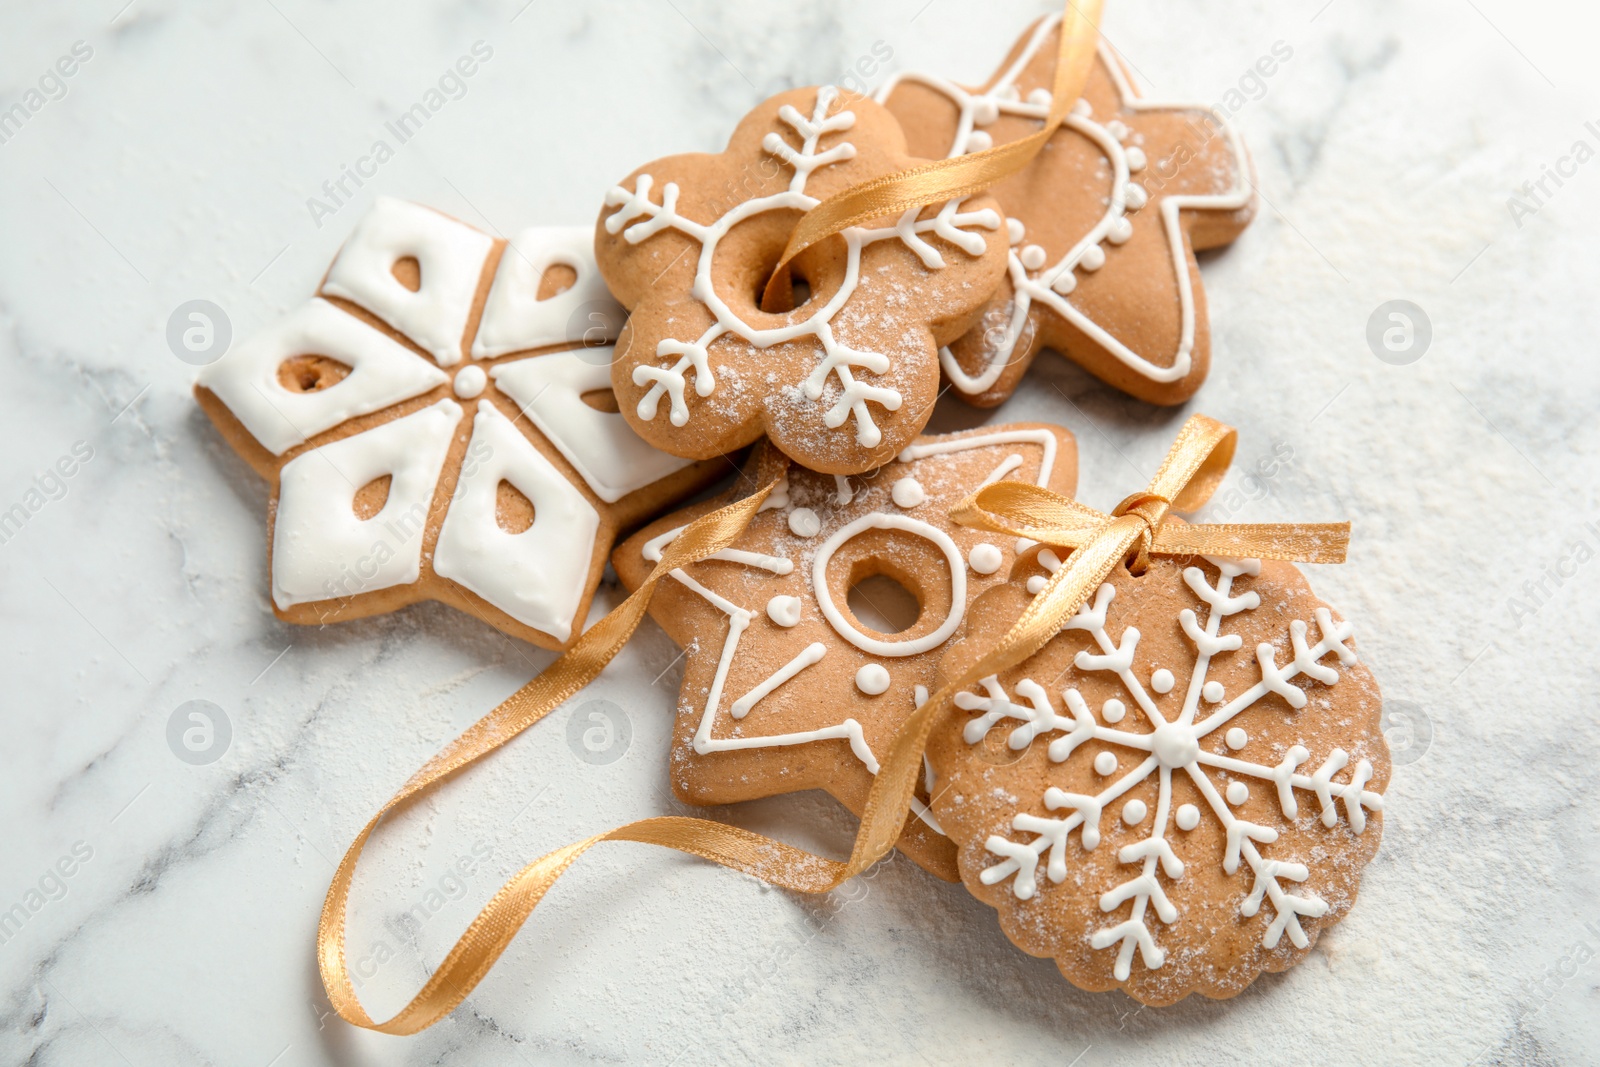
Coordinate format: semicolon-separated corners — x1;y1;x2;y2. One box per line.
928;549;1389;1005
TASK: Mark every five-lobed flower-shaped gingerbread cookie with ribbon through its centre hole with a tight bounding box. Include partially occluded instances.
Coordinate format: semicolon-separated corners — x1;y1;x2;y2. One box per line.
595;86;1006;474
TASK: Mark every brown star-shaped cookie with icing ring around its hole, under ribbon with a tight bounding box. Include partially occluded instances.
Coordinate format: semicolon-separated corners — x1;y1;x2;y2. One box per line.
613;424;1077;880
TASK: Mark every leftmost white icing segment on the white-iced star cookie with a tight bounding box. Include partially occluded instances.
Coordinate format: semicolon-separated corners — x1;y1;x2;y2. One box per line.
198;299;448;456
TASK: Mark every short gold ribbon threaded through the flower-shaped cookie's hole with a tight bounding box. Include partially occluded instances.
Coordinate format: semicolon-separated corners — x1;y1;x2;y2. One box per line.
762;0;1102;312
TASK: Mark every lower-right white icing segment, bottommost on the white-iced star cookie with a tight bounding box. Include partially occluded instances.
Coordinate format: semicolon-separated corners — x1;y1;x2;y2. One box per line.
434;400;600;641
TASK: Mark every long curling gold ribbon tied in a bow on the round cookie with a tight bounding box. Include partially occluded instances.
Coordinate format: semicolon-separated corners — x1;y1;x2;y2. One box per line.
317;414;1349;1033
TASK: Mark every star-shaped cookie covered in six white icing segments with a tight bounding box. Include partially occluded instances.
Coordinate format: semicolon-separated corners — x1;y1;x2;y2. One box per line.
195;198;723;648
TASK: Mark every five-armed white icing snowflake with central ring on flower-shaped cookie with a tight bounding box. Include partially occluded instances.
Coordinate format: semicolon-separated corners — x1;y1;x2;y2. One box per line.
605;86;1000;448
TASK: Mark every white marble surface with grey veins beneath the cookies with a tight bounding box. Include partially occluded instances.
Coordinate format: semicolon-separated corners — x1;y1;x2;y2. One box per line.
0;0;1600;1067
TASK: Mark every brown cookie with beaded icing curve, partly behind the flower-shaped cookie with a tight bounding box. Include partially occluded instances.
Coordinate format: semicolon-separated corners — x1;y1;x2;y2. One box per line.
878;16;1254;406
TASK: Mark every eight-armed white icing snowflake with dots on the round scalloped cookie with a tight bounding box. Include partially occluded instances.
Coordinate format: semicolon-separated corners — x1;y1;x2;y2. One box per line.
955;552;1382;981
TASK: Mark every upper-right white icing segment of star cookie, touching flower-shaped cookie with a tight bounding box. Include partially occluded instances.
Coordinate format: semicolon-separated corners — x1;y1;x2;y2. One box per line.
472;226;626;360
